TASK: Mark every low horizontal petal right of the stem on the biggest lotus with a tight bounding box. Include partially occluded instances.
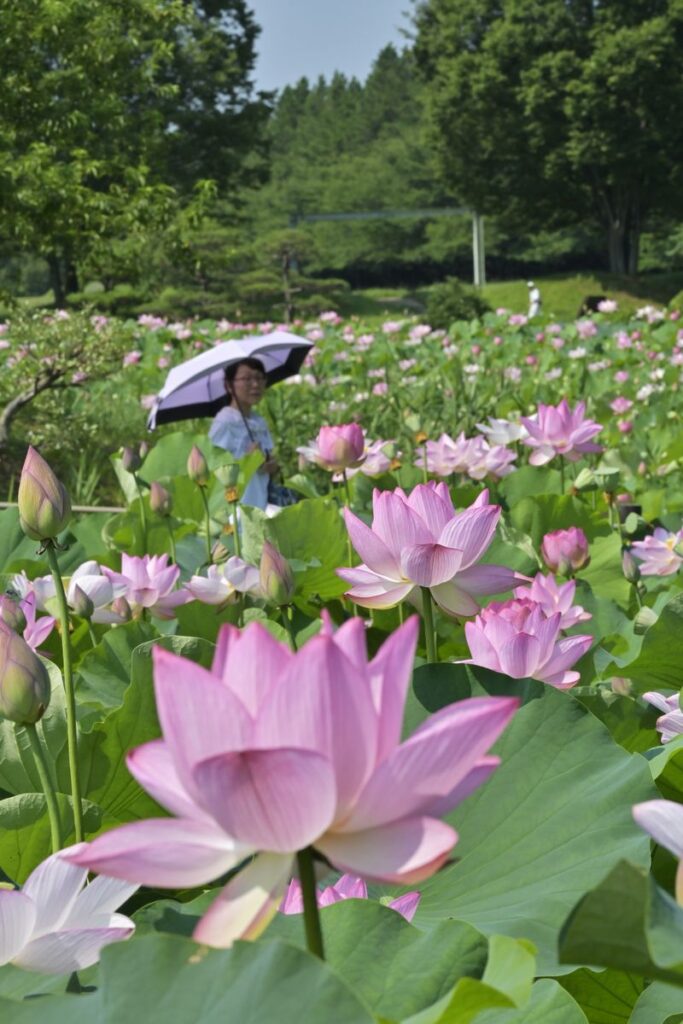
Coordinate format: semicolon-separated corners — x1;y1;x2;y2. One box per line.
315;817;458;885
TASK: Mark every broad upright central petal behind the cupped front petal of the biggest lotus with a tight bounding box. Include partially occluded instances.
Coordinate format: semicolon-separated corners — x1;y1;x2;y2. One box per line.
254;635;378;806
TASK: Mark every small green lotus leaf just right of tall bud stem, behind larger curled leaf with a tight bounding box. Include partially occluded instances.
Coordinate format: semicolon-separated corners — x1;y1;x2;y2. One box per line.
75;622;157;730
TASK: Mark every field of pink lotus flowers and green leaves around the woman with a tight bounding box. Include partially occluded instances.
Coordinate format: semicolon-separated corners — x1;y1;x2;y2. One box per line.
0;301;683;1024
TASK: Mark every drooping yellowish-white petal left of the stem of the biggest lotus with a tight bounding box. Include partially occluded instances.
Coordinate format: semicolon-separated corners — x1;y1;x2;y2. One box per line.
193;853;293;949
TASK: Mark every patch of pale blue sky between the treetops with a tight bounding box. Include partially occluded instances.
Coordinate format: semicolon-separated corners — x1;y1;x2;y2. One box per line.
250;0;411;89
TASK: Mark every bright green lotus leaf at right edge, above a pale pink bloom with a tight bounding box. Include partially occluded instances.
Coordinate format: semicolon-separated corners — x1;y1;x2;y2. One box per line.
620;594;683;693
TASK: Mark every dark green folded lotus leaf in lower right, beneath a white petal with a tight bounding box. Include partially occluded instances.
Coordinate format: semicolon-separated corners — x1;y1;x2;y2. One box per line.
560;860;683;997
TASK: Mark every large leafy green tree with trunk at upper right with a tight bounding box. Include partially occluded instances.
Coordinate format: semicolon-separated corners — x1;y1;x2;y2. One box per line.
415;0;683;273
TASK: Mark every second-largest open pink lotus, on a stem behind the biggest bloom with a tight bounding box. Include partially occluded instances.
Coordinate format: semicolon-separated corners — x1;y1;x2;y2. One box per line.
337;482;526;615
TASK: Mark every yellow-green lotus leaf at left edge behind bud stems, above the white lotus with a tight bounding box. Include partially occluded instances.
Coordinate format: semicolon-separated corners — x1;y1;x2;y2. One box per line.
0;793;102;885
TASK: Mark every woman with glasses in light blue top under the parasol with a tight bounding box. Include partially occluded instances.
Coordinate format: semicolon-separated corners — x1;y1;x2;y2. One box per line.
209;358;280;509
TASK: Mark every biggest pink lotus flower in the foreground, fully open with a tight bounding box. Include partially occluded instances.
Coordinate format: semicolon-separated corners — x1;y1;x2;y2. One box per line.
65;616;517;946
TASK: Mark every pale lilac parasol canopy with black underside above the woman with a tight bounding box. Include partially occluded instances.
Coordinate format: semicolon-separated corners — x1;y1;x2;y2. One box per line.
147;331;313;430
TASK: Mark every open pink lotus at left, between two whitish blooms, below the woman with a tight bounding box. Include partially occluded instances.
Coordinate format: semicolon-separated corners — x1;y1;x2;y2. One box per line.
102;552;190;618
